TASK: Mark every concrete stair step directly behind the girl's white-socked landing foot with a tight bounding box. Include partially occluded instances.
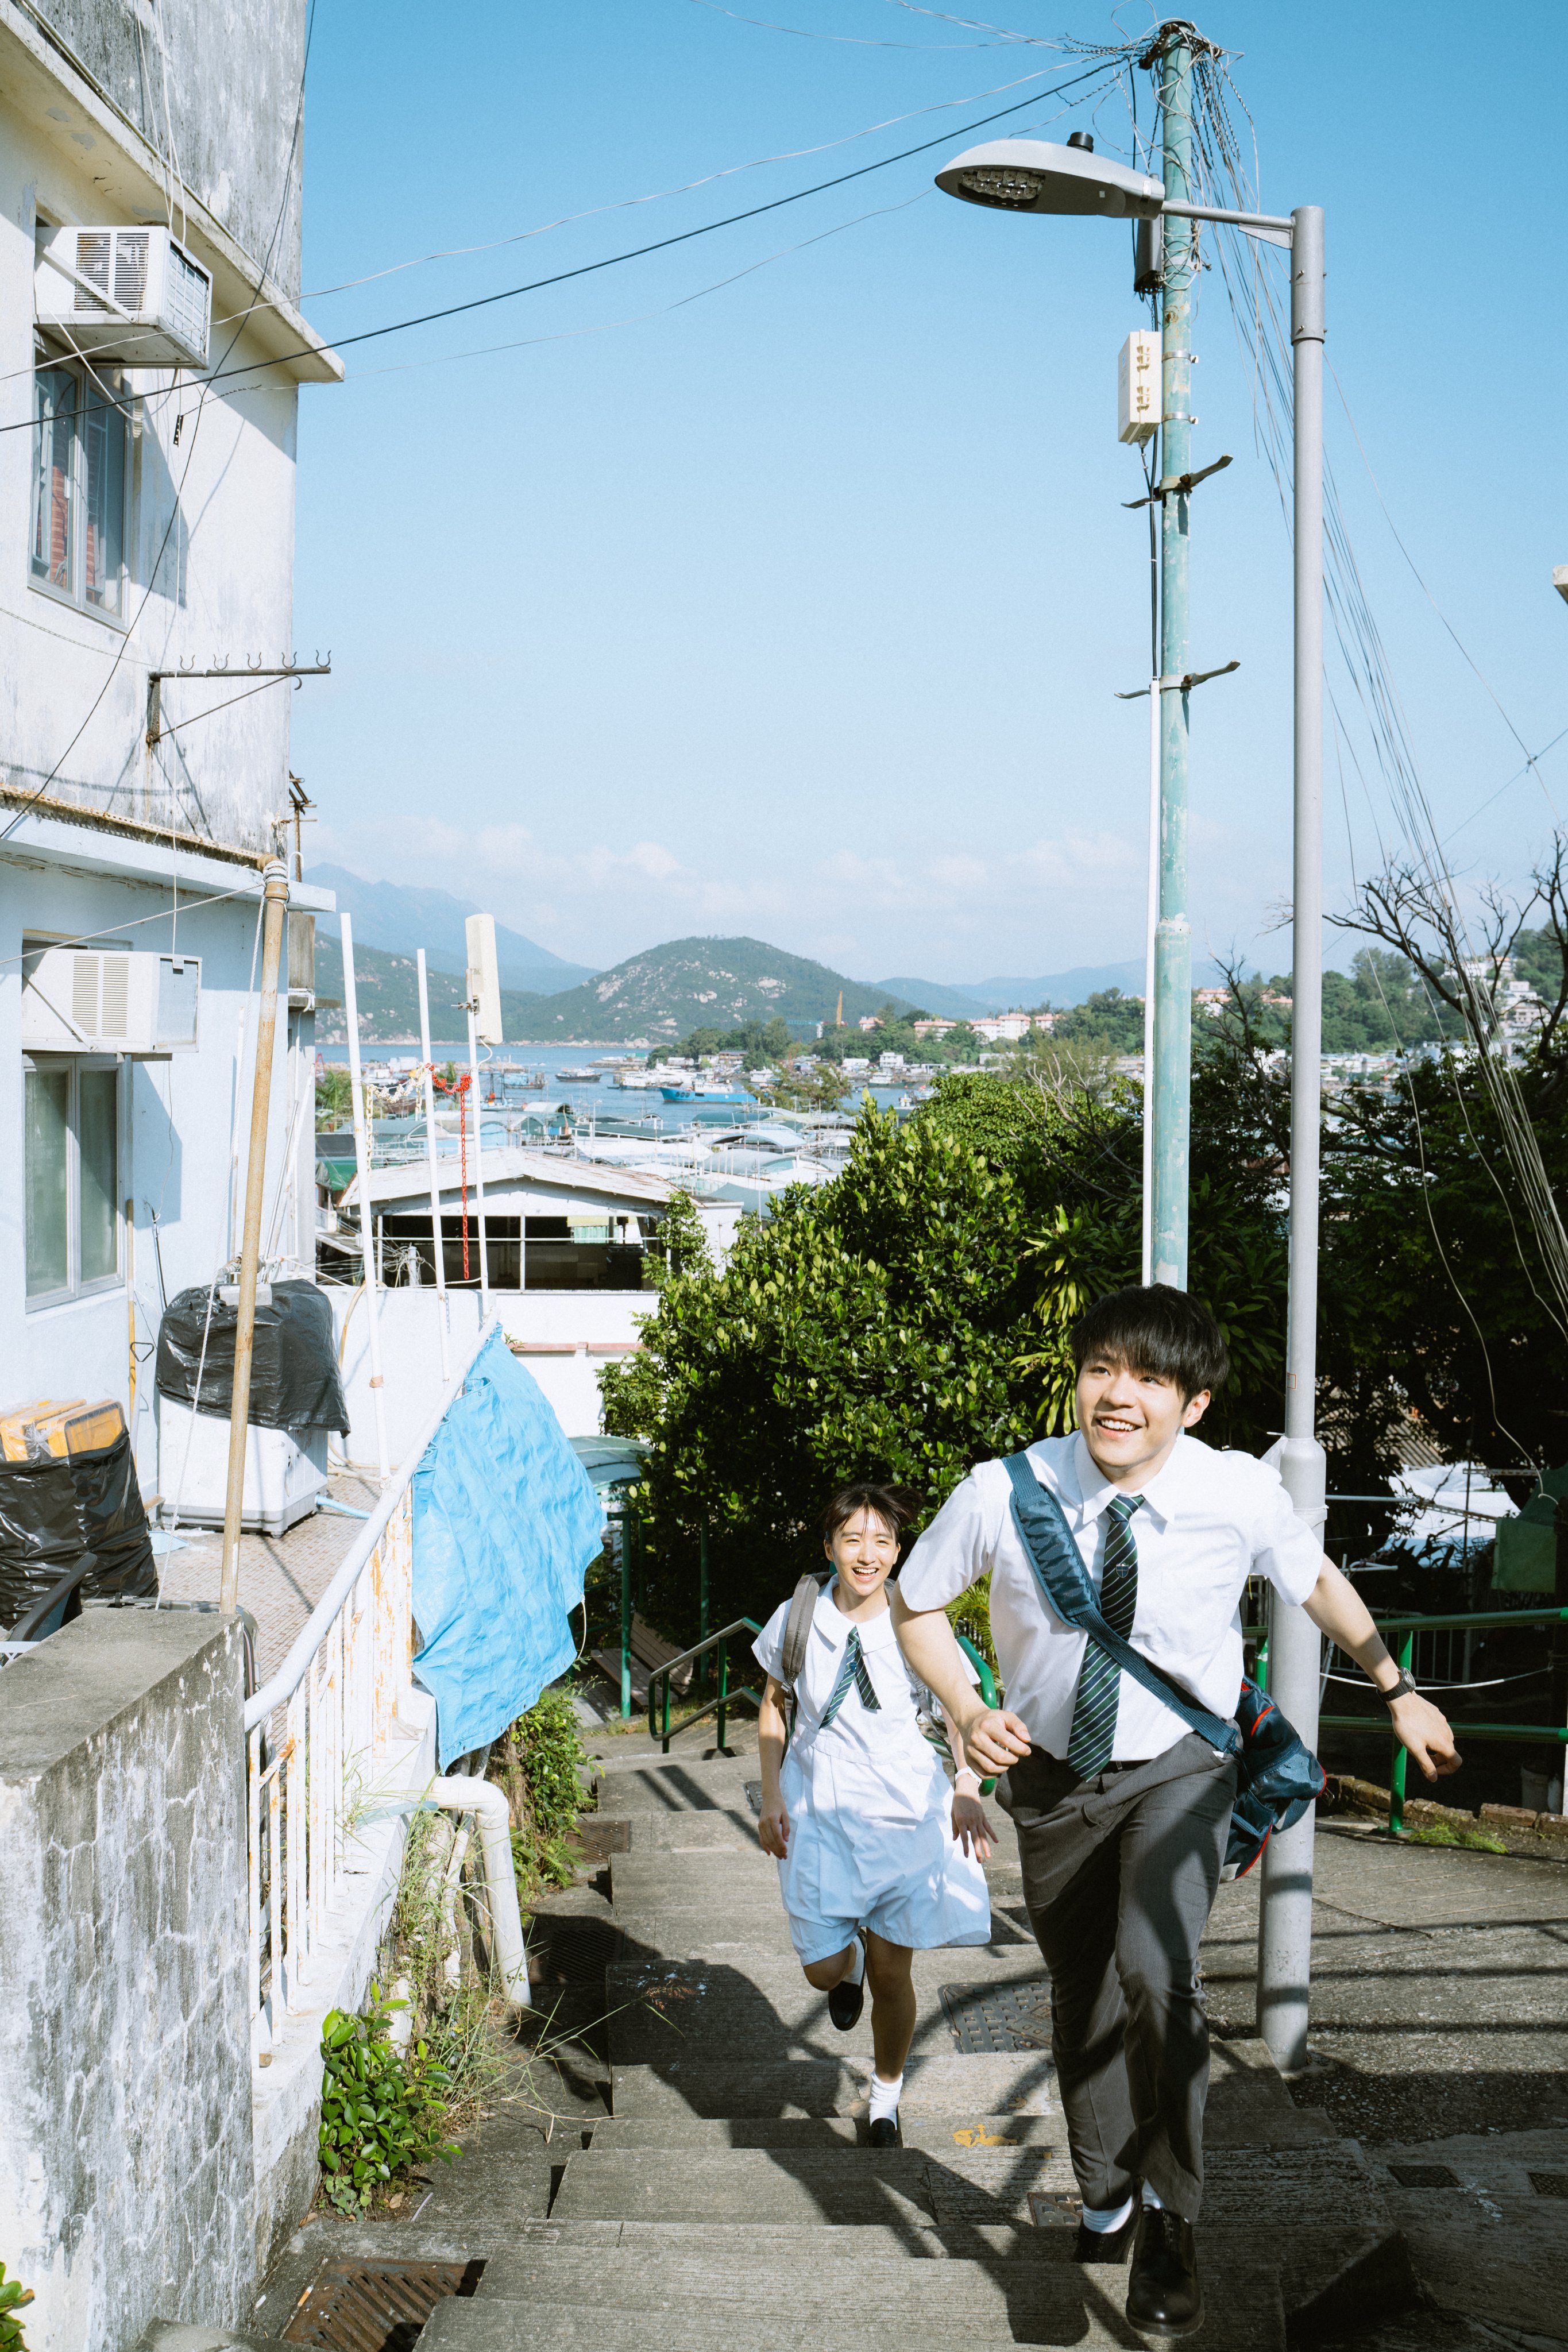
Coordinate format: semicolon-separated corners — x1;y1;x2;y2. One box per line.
611;2037;1056;2124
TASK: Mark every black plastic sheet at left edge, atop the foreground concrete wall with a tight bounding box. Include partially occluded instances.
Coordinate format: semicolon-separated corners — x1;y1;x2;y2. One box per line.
0;1432;157;1630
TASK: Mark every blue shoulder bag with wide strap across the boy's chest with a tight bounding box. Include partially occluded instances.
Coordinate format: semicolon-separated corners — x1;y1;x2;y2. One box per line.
1006;1454;1328;1879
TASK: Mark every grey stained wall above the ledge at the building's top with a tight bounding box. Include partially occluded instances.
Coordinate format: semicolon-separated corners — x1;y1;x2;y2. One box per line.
33;0;306;294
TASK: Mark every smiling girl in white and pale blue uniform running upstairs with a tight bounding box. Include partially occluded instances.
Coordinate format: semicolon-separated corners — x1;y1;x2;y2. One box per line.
755;1484;992;2148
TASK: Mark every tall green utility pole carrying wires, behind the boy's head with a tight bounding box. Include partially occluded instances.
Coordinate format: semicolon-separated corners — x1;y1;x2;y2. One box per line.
1152;24;1196;1291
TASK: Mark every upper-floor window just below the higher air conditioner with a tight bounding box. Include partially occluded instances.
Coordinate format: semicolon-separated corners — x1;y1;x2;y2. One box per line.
30;367;127;614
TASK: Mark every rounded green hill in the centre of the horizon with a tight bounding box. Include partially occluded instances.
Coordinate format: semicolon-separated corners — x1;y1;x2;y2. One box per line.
508;939;921;1044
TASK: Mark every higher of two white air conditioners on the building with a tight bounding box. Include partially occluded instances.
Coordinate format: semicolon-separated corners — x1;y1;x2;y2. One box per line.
33;226;211;367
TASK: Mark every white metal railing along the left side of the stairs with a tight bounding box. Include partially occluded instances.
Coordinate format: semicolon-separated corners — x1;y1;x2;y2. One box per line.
245;1319;499;2065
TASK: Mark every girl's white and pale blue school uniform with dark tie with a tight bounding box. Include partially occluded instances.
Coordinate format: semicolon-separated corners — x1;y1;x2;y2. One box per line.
752;1583;992;1966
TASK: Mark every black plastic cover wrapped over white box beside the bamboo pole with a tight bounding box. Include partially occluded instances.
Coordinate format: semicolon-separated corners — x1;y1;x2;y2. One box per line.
157;1282;348;1437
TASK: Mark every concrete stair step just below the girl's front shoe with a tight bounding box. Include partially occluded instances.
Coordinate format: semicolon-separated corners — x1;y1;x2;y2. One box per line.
550;2148;936;2227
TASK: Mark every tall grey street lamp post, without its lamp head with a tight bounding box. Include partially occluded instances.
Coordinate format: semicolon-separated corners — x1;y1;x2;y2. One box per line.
1258;204;1328;2075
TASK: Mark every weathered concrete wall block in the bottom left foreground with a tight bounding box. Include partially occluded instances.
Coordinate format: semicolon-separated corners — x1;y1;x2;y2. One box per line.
0;1611;256;2352
